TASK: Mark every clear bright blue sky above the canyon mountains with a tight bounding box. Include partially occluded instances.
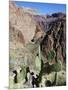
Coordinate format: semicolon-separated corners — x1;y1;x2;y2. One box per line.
15;1;66;14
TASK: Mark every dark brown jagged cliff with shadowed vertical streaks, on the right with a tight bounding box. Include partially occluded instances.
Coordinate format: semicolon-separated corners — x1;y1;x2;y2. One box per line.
41;17;66;62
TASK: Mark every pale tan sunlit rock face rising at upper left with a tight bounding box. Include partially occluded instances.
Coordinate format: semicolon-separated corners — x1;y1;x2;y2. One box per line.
9;2;36;47
